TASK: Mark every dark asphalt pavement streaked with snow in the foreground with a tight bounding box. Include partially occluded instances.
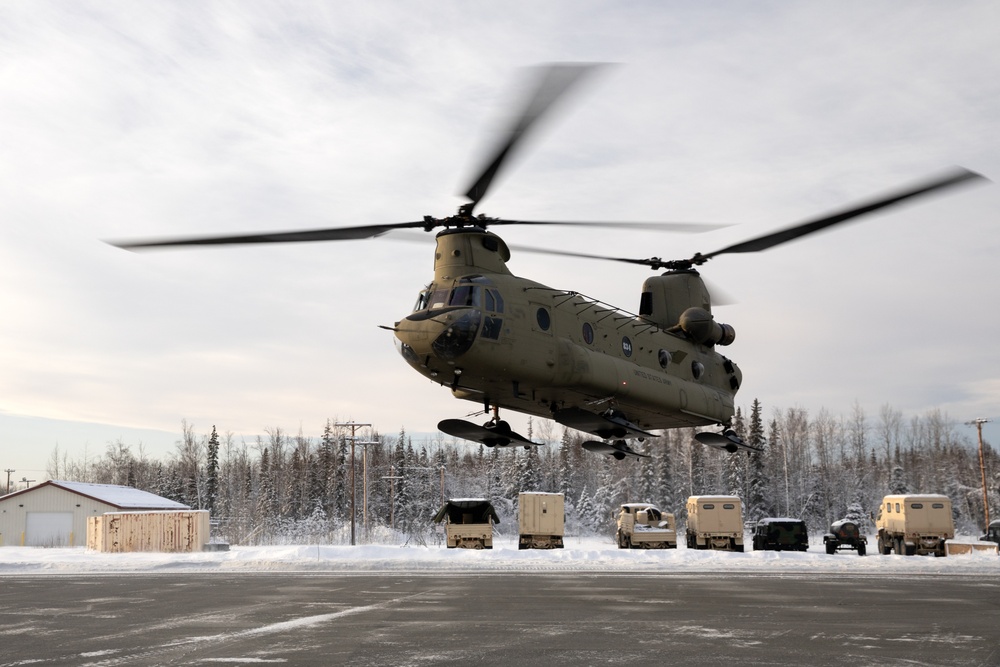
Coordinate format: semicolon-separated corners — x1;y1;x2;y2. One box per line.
0;572;1000;667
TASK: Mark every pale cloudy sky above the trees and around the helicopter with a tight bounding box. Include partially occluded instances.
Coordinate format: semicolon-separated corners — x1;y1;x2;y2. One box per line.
0;0;1000;479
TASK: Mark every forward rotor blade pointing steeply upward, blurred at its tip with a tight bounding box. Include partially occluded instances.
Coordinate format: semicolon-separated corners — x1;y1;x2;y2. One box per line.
465;64;601;208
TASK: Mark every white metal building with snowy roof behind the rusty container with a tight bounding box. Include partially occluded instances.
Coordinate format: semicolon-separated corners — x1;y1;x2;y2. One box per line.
0;480;191;547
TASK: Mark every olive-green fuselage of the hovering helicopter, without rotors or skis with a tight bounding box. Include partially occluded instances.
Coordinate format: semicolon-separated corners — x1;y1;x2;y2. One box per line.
394;227;742;430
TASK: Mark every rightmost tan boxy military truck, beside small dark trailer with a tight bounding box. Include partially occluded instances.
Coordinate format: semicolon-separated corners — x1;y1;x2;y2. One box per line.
875;494;955;556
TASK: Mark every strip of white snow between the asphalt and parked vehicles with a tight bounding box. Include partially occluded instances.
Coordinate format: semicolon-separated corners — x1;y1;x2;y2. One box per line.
0;537;1000;576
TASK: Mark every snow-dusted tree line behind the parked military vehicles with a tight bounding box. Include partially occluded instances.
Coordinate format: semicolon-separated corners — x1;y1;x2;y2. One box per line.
39;400;1000;545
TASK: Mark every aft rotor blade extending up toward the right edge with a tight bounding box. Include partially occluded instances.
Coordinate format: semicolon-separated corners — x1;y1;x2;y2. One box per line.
696;167;988;264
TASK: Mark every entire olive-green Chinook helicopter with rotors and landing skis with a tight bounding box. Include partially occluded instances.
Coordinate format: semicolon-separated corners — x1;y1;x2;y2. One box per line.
114;65;982;459
